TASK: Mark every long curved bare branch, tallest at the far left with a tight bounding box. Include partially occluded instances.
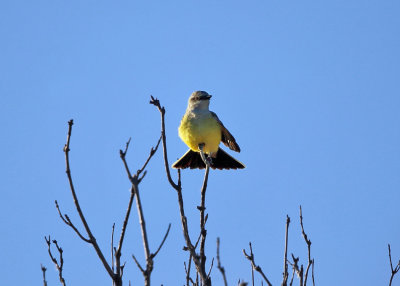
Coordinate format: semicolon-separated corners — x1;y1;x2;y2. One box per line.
64;119;114;280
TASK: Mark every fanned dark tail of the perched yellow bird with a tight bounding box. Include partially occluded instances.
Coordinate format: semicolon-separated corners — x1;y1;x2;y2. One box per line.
172;148;245;170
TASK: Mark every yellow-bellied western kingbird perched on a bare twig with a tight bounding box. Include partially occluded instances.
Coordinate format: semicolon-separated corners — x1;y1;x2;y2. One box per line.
172;91;245;170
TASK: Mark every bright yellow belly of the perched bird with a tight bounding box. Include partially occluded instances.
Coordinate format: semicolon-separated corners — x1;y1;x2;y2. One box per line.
179;114;221;154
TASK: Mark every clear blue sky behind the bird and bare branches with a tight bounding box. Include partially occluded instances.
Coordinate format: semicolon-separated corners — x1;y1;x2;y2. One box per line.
0;0;400;285
